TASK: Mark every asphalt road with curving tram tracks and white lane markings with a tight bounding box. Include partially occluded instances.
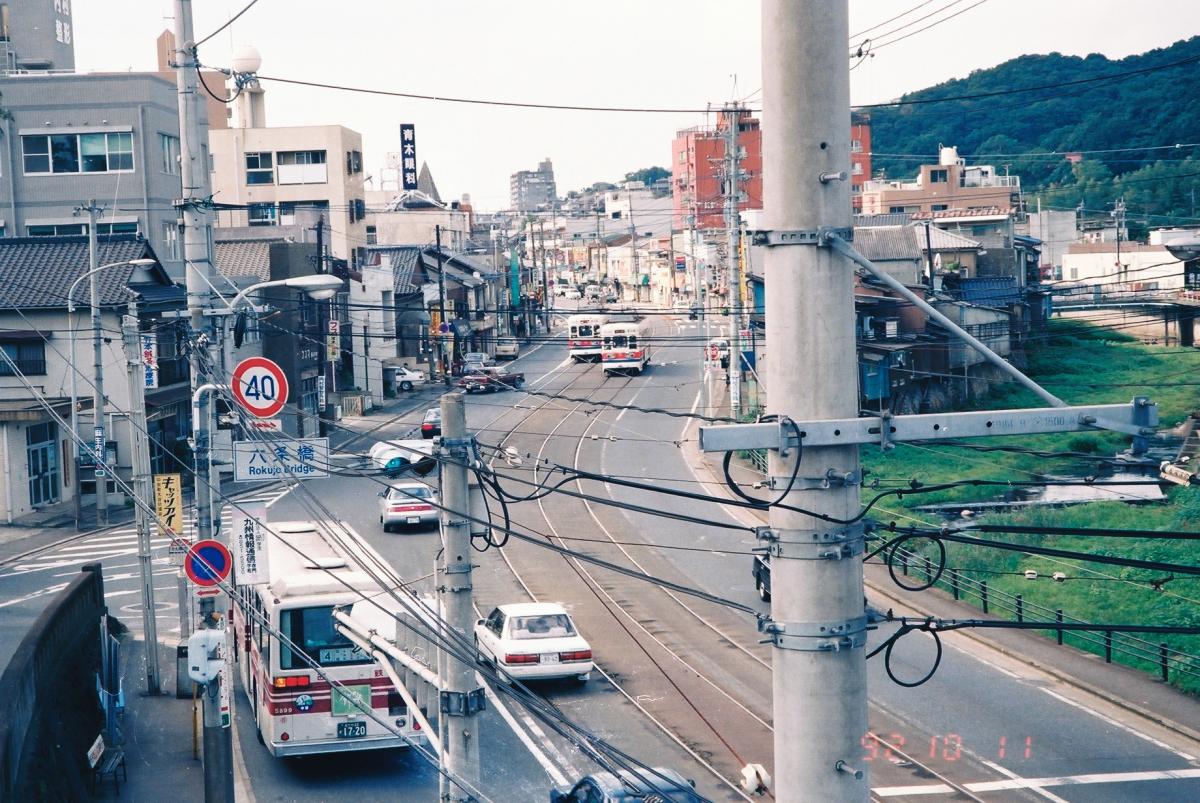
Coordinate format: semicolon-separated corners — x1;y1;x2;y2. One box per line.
0;307;1200;801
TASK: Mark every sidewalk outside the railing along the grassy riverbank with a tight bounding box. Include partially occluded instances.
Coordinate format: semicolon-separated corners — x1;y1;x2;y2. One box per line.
690;432;1200;742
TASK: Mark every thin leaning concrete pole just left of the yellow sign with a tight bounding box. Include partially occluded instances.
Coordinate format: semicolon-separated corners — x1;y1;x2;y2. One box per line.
121;301;162;695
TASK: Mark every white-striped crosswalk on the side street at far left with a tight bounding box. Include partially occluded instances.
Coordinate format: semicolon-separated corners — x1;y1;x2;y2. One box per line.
0;489;289;637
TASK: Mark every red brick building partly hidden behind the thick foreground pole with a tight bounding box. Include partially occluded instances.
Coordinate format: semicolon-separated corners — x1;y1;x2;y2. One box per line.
671;112;871;230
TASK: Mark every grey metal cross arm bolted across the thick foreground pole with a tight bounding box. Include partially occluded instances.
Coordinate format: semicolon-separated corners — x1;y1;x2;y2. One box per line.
700;397;1158;451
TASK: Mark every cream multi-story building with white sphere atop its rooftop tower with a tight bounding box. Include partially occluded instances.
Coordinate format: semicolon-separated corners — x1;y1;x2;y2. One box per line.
209;88;367;264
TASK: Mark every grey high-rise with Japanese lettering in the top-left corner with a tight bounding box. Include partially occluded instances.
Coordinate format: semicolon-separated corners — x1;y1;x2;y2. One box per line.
0;0;74;73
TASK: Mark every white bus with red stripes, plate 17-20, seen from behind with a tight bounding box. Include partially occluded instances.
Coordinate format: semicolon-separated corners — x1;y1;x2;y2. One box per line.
233;521;424;756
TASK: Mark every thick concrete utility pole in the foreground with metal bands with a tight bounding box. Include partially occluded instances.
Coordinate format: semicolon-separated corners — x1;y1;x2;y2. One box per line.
762;0;870;803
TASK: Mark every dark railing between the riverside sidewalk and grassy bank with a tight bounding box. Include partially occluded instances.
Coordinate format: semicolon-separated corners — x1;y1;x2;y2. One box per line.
895;550;1200;682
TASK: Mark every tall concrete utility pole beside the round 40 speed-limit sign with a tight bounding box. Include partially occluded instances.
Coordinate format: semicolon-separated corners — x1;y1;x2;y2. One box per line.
174;0;233;803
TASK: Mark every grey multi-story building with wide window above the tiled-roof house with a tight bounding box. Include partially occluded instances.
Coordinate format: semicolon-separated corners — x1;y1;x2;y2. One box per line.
0;72;192;278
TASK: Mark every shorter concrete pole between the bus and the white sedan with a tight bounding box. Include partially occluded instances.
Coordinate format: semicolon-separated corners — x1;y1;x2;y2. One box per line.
438;392;484;801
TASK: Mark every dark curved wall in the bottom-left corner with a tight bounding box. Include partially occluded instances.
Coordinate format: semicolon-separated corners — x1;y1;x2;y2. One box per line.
0;563;106;801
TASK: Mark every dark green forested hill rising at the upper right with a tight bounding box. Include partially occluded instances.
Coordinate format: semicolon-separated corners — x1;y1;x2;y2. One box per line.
863;36;1200;223
